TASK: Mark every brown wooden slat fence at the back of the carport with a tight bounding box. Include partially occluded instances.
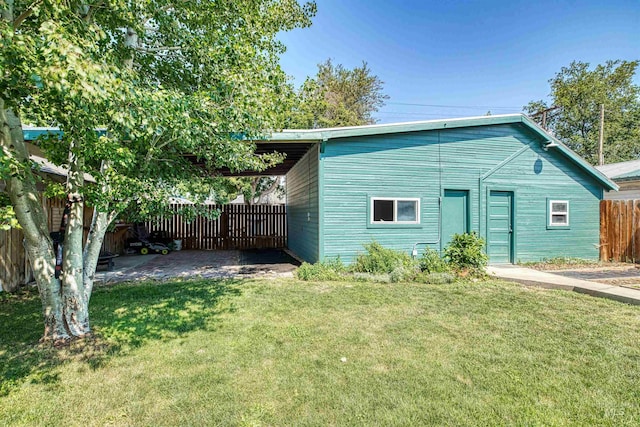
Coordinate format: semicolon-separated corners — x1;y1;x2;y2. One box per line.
147;205;287;250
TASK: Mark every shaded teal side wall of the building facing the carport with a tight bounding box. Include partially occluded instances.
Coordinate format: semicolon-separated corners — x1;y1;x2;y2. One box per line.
286;145;320;263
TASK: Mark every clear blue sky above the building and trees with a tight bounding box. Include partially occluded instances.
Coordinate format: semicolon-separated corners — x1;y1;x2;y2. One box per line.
280;0;640;123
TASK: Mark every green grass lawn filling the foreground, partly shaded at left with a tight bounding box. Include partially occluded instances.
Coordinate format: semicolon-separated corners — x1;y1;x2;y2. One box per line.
0;279;640;426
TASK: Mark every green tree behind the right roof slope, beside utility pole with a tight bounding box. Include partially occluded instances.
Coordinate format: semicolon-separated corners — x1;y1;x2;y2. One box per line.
524;61;640;164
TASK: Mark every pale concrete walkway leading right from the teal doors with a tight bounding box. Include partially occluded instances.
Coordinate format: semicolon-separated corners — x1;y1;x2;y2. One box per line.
487;265;640;305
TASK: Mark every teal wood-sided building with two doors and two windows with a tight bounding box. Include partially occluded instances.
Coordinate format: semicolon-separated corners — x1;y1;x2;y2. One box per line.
268;114;617;264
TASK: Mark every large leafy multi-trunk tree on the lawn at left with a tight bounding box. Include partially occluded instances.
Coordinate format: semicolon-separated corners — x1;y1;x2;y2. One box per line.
0;0;315;340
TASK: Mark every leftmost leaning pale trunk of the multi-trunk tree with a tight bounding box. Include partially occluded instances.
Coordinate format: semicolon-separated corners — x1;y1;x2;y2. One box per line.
0;99;70;341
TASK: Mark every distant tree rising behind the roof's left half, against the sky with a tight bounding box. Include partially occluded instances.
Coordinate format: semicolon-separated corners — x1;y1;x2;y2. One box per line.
288;59;389;129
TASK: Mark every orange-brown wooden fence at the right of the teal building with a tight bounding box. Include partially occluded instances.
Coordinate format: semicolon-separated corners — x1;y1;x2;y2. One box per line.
600;200;640;262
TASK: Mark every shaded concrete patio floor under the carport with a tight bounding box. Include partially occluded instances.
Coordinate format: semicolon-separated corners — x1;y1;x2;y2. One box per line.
96;249;298;285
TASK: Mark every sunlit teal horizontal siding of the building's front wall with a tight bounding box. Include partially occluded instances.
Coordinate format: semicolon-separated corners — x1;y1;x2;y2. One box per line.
320;124;602;262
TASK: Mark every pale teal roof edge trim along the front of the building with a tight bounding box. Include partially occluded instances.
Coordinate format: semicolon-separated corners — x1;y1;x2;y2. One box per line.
268;114;618;190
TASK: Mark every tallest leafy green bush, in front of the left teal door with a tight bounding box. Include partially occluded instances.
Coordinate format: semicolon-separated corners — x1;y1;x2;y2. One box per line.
444;231;489;274
